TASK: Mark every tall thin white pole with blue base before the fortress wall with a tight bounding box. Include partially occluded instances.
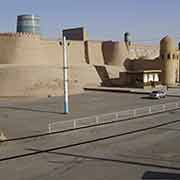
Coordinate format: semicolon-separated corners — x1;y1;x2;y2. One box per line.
63;36;69;114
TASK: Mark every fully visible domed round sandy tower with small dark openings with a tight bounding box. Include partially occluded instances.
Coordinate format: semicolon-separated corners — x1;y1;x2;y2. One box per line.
160;36;178;87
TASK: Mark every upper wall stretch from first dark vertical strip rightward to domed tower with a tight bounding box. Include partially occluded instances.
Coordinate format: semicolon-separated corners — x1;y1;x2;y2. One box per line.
85;41;161;72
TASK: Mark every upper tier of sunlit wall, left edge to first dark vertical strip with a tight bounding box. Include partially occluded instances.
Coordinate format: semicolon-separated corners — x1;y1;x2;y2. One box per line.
0;33;86;65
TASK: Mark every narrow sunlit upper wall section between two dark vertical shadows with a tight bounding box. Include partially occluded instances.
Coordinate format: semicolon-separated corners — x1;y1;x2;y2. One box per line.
85;41;104;65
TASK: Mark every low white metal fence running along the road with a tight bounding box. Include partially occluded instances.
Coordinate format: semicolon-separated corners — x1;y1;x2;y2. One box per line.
48;102;180;133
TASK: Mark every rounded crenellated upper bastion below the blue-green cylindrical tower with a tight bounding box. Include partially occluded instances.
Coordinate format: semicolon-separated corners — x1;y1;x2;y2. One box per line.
0;33;44;64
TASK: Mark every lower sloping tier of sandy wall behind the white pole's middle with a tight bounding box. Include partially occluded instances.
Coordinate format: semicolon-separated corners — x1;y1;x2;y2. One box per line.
0;65;100;96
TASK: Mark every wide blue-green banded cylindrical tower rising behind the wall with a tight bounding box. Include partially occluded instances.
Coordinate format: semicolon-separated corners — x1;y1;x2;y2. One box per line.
17;14;40;34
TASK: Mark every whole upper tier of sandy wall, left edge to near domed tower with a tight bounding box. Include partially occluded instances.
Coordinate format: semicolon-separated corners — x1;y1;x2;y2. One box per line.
0;33;158;67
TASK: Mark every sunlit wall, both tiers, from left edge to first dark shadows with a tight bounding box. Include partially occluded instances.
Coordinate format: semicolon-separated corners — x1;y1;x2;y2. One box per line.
0;33;94;96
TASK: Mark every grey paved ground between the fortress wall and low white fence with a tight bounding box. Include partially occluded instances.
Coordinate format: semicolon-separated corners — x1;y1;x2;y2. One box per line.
0;92;180;138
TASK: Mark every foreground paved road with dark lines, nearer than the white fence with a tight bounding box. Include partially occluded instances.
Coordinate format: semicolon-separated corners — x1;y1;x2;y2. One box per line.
0;111;180;180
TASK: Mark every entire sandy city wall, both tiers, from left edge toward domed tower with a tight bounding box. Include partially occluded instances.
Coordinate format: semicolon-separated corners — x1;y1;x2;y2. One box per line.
0;33;159;96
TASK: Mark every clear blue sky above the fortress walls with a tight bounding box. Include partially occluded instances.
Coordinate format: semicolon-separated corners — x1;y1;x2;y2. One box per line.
0;0;180;43
